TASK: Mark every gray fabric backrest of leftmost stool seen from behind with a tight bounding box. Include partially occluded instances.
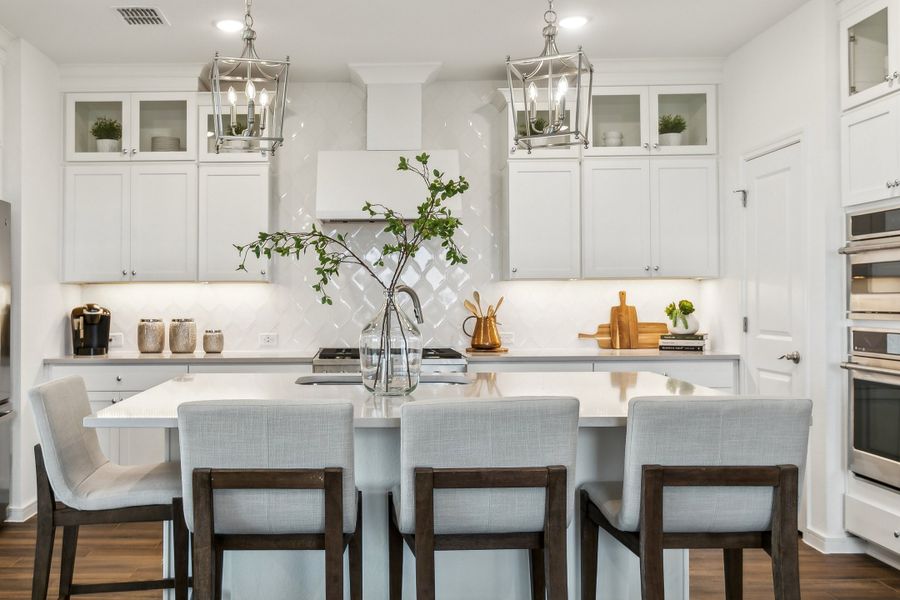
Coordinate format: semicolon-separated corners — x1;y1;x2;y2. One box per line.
178;400;356;534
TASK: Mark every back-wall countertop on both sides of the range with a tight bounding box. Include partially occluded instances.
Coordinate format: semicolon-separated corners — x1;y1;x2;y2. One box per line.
44;348;740;365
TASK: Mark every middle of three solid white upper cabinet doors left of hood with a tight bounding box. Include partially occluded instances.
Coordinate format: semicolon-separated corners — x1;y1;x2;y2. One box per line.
131;165;197;281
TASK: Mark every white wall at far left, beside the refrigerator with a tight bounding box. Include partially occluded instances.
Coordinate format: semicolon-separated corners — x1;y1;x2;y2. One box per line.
3;40;80;519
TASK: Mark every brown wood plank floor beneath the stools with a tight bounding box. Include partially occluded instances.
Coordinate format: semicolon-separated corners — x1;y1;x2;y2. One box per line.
0;522;900;600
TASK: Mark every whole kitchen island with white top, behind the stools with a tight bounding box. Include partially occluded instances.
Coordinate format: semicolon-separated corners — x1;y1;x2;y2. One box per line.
84;372;719;600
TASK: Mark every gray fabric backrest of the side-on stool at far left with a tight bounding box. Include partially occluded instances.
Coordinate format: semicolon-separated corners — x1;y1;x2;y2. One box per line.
31;376;109;505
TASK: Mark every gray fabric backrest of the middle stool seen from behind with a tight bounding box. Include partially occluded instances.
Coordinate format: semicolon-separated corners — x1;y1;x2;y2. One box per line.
400;397;579;533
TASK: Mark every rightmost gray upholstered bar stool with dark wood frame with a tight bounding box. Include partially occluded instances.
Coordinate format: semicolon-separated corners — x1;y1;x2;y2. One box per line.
579;398;812;600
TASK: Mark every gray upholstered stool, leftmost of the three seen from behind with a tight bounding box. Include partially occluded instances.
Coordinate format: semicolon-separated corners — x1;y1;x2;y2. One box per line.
178;401;362;600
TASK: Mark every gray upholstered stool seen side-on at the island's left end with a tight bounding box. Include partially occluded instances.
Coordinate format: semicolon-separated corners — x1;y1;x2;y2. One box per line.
31;377;188;600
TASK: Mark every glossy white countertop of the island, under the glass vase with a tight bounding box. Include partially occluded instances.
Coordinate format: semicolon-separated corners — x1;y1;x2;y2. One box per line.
84;372;721;429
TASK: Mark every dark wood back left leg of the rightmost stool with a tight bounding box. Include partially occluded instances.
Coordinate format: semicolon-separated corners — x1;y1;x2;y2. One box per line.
640;466;665;600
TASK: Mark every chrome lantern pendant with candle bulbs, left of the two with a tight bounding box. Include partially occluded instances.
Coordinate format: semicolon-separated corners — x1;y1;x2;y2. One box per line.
210;0;290;155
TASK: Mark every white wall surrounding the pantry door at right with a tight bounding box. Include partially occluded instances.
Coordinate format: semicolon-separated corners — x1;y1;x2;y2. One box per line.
702;0;846;549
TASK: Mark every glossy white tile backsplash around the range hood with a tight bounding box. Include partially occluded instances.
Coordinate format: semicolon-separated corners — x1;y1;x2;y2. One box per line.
82;82;704;351
